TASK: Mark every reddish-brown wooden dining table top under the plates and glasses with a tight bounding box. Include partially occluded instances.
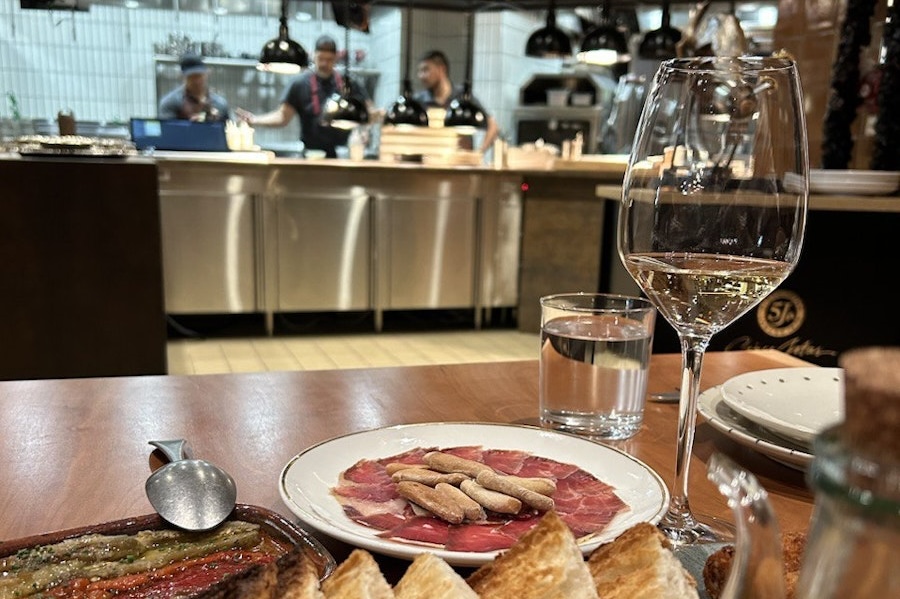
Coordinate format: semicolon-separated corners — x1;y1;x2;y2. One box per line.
0;350;812;578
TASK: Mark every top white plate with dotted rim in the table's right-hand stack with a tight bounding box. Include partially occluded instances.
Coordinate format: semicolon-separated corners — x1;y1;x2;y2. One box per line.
722;367;844;447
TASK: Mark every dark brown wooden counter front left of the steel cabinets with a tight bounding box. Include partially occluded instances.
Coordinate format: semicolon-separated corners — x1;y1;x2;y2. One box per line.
0;158;166;379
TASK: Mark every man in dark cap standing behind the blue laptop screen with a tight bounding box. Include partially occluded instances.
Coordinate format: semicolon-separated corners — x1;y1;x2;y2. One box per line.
158;54;231;121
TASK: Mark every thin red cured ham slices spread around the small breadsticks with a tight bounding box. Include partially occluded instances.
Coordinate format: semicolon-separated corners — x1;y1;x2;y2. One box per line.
332;446;628;552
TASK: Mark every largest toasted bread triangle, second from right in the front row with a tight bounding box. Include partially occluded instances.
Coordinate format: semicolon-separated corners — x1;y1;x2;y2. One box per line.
468;511;598;599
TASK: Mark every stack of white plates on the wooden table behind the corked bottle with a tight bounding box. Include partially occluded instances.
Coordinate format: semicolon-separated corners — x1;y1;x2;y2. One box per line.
699;367;844;469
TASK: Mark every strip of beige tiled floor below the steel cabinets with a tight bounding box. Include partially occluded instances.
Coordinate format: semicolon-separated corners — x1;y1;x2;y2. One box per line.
168;329;540;374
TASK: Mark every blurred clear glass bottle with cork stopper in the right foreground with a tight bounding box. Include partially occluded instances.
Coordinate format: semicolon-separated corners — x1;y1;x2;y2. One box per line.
796;347;900;599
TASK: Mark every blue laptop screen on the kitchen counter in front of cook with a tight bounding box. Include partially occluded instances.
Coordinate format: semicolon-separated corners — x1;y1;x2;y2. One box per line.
130;118;228;152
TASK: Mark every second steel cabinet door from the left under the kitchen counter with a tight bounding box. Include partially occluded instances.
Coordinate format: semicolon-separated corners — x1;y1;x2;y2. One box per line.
277;188;372;312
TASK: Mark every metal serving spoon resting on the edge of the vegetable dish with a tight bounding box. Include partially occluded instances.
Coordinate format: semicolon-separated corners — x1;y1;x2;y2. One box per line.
144;439;237;530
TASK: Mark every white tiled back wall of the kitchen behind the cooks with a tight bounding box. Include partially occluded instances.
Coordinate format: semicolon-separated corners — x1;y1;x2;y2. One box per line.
0;0;561;144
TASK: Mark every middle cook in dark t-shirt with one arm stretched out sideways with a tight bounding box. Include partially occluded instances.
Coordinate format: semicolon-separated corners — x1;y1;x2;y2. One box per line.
235;35;369;158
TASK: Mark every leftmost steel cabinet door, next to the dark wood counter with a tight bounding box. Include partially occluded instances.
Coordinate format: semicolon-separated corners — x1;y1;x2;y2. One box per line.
160;192;259;314
